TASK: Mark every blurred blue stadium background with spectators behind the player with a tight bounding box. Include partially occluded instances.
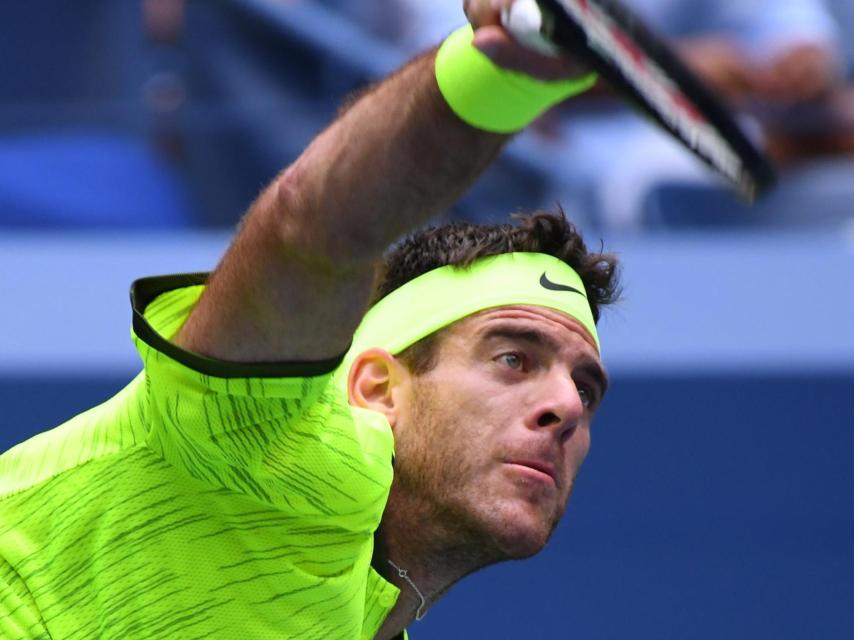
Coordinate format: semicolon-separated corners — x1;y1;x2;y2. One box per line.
0;0;854;640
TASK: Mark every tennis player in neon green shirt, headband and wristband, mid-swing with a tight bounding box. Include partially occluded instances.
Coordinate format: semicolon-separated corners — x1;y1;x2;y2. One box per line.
0;0;616;640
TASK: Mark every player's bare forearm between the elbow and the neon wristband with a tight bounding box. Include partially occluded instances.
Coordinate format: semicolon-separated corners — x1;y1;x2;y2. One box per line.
275;53;507;267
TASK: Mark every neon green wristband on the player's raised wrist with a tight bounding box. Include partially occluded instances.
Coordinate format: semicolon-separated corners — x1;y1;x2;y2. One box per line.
436;25;596;133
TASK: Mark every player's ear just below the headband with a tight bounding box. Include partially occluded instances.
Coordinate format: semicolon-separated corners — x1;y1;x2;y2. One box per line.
347;348;409;428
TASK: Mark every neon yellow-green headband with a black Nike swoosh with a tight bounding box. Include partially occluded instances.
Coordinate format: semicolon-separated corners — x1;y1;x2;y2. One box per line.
338;253;601;385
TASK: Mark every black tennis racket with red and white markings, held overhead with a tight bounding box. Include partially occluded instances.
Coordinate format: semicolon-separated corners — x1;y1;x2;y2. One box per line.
502;0;776;202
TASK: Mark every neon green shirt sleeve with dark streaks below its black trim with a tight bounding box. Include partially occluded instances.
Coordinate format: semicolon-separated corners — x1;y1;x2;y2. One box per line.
129;278;394;534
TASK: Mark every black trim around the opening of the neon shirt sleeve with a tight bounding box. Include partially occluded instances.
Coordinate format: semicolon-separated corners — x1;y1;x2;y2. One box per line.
130;273;345;378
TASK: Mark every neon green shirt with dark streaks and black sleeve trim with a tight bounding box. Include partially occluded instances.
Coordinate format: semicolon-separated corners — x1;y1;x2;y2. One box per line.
0;276;398;640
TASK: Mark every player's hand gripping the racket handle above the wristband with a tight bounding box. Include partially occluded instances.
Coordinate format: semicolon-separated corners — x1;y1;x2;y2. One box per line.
463;0;590;80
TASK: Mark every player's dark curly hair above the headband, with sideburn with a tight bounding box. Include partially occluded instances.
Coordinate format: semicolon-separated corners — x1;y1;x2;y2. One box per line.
373;210;620;374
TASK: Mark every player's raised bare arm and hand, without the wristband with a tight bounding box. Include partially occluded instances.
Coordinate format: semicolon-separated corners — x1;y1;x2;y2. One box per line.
177;0;588;362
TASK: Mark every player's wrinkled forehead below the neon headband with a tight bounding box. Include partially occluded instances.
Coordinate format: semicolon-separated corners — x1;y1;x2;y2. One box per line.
448;305;599;360
